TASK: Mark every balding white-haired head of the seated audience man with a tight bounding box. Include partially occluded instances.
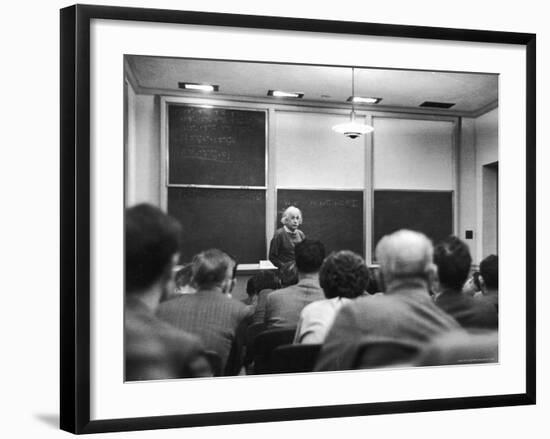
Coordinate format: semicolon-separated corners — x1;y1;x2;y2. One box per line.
376;230;434;283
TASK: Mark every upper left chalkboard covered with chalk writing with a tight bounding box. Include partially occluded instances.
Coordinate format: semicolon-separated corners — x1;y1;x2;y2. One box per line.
168;105;266;186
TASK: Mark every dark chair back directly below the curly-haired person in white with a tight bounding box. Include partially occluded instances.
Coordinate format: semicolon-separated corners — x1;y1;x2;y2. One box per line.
271;343;322;373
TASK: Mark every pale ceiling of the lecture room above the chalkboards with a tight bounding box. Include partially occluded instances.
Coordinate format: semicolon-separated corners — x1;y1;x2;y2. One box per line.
125;56;498;116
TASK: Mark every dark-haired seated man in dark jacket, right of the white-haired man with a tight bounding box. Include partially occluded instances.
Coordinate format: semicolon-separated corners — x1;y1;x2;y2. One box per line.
434;236;498;330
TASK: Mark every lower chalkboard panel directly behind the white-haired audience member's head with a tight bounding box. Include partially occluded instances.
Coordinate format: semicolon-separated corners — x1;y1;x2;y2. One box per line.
372;190;453;254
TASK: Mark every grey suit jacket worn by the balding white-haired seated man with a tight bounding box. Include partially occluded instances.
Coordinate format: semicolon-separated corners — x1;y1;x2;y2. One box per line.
315;278;460;371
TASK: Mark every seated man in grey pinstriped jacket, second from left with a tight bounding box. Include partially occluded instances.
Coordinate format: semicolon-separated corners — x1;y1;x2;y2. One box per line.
157;249;250;374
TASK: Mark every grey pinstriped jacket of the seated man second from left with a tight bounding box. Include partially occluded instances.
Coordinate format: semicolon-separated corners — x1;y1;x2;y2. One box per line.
157;290;251;374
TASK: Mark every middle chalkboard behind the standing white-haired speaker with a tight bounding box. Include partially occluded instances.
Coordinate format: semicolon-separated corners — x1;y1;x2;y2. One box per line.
276;189;365;257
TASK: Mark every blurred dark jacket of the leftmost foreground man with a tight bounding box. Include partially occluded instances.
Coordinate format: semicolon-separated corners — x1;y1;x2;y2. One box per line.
124;297;212;381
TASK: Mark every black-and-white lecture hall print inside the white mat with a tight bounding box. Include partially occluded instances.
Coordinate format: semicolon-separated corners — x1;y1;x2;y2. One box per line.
126;55;502;381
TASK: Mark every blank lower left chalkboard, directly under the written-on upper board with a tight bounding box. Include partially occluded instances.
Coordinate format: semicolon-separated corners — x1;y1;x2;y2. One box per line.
168;187;266;264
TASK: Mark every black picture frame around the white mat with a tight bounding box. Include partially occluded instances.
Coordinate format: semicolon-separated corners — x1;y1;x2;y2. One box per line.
60;5;536;434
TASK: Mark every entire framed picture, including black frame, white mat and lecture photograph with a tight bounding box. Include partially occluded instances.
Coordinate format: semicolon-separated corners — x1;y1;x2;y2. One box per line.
55;5;536;433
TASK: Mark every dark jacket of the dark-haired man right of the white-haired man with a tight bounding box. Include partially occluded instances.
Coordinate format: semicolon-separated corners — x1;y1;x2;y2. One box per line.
435;290;498;330
